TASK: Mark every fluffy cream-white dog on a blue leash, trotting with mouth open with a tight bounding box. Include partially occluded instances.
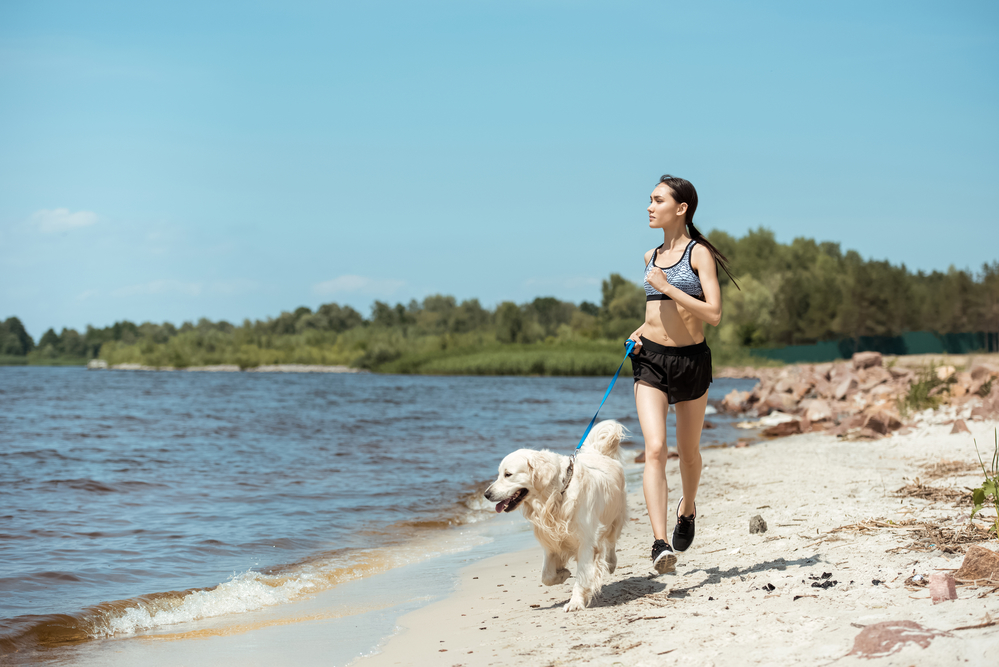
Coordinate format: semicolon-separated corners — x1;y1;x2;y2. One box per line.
485;420;628;611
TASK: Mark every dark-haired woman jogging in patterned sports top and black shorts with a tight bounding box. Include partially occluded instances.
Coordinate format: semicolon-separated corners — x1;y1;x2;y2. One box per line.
630;175;731;574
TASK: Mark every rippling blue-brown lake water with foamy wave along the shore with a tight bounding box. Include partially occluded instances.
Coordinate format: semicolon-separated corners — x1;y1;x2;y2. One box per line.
0;367;753;654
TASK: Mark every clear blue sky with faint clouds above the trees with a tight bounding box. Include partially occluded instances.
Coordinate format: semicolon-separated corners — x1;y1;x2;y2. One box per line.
0;0;999;340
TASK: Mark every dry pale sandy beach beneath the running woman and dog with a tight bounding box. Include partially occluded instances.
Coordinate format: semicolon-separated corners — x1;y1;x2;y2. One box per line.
355;419;999;667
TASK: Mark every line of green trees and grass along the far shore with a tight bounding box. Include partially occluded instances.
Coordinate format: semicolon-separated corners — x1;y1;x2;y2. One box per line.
0;228;999;370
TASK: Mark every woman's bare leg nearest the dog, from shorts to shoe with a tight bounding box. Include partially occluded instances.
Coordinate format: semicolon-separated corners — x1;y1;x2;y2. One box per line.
635;382;669;542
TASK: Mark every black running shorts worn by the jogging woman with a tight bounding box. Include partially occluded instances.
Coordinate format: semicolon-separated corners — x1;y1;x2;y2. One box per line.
631;336;711;405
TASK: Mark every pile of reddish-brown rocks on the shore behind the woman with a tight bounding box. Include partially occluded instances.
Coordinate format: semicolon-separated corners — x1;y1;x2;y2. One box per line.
721;352;999;439
